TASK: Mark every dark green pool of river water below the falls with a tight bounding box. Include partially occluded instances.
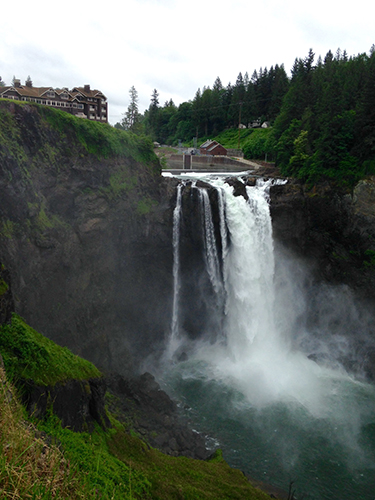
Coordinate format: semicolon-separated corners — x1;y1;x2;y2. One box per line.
163;360;375;500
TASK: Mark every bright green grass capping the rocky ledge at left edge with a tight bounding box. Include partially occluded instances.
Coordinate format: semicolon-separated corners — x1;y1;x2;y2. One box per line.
0;314;101;386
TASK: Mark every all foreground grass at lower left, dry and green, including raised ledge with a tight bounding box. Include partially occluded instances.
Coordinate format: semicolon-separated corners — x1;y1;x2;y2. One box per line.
0;315;269;500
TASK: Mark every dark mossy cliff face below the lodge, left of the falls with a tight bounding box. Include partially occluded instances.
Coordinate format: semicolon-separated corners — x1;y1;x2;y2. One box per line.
0;101;177;374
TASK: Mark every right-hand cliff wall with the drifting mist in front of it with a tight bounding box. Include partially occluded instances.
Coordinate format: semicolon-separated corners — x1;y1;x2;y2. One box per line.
270;179;375;381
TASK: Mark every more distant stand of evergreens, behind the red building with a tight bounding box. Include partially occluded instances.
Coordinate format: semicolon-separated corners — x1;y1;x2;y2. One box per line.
115;65;289;144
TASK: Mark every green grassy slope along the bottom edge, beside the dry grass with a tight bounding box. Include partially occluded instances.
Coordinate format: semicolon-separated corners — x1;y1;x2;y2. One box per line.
38;410;269;500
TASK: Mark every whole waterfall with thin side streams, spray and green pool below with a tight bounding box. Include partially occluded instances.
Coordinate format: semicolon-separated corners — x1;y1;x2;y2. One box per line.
164;173;375;500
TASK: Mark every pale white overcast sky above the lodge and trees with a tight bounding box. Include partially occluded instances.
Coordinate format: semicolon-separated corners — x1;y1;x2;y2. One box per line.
0;0;375;124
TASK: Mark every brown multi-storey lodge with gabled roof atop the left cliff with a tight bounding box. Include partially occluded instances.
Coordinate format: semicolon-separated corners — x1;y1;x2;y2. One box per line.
0;79;108;123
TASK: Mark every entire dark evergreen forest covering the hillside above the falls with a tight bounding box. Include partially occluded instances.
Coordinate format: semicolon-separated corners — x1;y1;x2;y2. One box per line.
116;45;375;185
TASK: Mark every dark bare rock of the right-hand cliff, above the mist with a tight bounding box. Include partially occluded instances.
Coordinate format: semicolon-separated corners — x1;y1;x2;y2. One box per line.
270;178;375;302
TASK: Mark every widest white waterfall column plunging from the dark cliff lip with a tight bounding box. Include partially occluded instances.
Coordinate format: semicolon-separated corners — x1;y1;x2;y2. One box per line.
222;183;274;357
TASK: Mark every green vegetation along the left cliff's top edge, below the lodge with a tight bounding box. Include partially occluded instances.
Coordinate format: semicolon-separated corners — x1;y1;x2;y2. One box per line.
0;99;160;176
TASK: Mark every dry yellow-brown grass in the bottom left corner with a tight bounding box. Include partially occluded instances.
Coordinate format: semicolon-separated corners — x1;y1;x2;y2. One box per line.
0;367;87;500
